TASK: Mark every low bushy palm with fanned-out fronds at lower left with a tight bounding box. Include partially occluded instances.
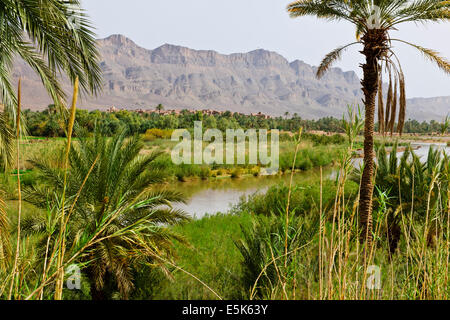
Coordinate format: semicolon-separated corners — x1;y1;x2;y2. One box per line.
23;129;188;299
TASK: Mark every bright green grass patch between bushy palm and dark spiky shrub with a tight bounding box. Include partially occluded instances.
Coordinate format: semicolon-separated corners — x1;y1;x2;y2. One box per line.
147;213;252;300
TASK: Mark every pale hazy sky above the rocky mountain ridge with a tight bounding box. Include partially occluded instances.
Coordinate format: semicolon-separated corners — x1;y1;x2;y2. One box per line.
82;0;450;97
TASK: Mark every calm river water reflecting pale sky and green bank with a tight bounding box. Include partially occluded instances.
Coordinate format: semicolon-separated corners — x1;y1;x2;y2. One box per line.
174;143;450;219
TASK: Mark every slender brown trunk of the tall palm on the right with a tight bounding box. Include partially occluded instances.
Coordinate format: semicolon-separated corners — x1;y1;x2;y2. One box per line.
359;30;386;247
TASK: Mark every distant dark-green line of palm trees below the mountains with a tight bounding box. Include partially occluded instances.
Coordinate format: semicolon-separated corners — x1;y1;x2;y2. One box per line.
24;106;441;137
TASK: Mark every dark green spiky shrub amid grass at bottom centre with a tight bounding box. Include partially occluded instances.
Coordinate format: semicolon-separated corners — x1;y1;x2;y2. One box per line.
235;212;319;299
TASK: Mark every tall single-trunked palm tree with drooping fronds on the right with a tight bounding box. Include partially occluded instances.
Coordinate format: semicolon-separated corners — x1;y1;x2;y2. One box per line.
287;0;450;243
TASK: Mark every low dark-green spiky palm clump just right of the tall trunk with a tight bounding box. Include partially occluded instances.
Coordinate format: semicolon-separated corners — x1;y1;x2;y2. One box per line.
352;142;450;254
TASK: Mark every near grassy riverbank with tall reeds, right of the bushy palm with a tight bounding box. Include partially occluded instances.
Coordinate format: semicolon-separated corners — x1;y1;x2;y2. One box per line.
142;141;450;299
